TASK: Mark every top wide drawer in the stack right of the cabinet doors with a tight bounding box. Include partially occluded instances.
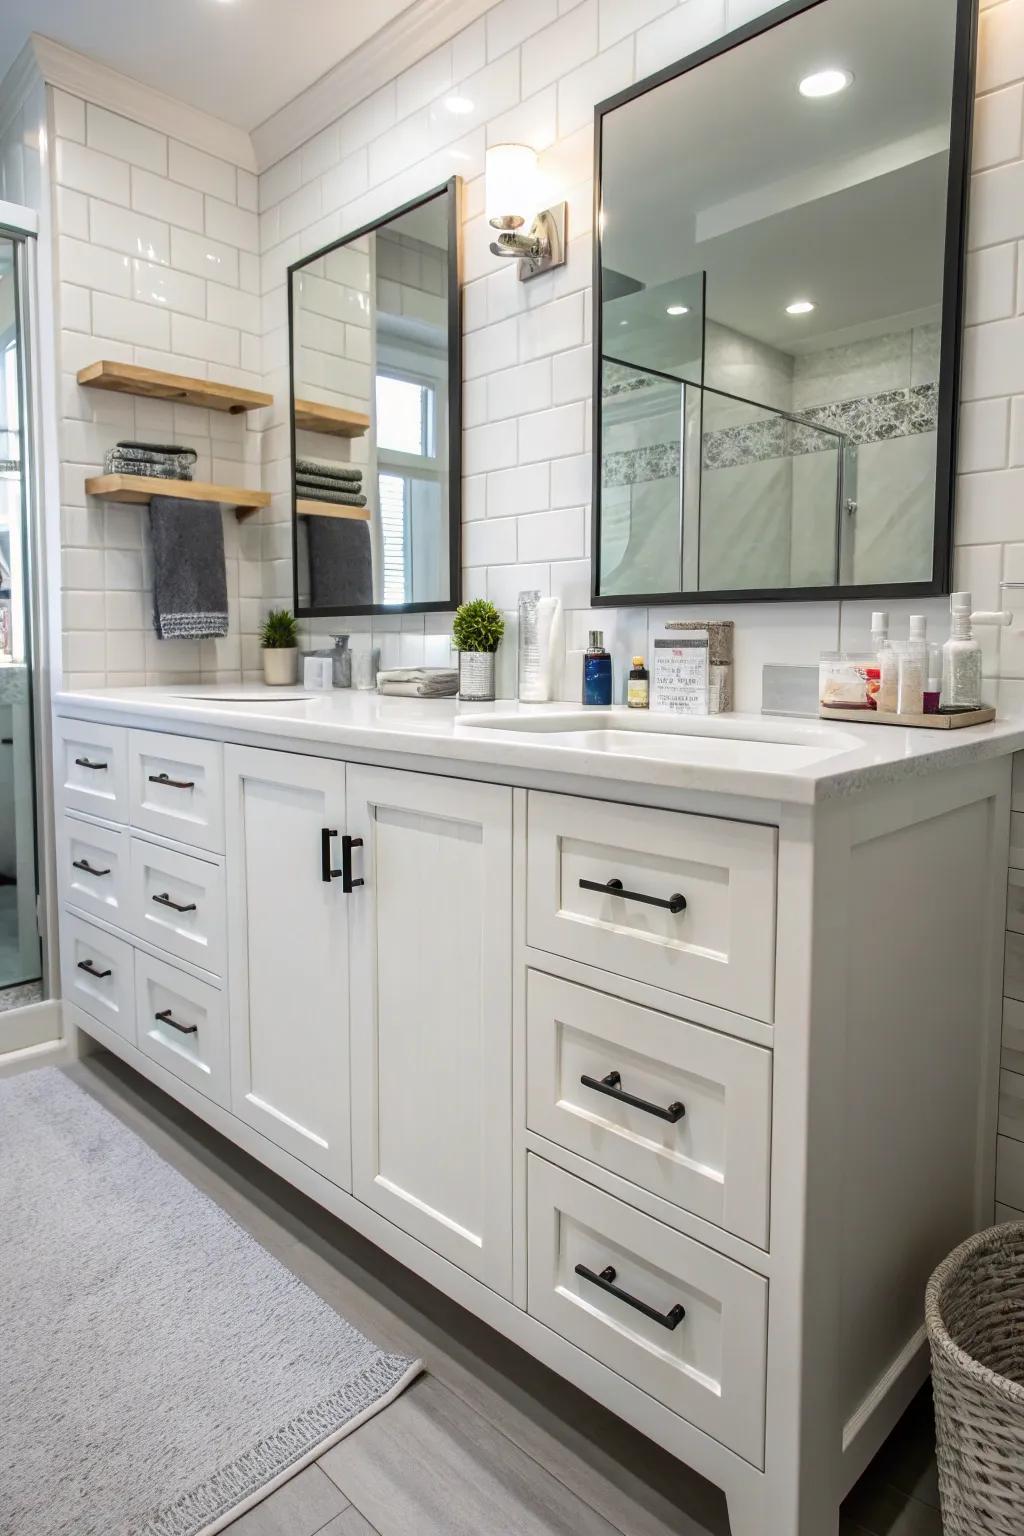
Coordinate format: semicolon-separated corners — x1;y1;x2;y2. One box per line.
527;791;777;1023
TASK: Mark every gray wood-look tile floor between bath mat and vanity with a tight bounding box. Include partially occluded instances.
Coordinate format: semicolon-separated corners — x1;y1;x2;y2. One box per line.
68;1054;941;1536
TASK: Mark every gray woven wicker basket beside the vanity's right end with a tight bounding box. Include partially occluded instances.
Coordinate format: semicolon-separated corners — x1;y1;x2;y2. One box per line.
924;1221;1024;1536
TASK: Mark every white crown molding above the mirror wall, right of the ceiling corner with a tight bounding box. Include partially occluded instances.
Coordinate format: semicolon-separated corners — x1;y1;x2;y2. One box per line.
252;0;497;170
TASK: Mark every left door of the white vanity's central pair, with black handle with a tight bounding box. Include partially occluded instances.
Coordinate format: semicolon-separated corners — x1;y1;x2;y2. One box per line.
224;746;353;1189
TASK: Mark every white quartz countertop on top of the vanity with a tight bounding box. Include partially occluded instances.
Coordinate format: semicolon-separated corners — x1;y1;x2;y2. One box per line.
54;684;1024;805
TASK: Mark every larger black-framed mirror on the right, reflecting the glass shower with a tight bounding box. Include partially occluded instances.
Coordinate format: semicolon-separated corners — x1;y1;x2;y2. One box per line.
591;0;975;605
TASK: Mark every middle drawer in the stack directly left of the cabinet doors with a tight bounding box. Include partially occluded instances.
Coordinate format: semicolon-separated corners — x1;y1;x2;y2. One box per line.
129;837;226;975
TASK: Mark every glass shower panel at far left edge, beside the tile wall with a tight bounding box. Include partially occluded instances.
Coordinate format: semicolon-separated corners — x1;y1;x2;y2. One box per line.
0;235;41;1011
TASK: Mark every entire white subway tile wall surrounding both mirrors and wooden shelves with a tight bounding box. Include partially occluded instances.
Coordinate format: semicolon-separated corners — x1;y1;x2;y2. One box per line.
37;0;1024;708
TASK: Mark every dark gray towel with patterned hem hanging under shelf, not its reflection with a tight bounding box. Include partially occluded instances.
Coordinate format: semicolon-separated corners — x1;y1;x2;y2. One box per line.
149;496;227;641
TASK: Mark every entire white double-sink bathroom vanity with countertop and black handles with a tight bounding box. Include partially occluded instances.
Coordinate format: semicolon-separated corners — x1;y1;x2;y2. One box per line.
55;688;1024;1536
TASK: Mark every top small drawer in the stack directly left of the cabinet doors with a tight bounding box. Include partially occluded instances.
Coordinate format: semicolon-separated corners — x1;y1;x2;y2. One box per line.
127;731;224;854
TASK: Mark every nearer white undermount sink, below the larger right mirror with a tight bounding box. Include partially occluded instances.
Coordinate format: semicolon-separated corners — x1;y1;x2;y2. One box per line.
459;708;861;773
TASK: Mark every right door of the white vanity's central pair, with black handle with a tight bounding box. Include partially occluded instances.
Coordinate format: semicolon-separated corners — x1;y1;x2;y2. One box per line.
348;765;511;1295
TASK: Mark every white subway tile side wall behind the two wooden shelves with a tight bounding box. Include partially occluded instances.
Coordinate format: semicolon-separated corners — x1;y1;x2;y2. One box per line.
51;91;264;687
